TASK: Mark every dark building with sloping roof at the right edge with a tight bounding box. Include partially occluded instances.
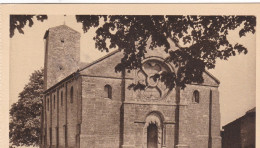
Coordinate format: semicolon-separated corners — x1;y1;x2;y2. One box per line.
221;108;256;148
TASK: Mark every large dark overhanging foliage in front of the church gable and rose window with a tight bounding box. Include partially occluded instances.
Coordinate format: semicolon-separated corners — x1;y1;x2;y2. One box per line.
76;15;256;89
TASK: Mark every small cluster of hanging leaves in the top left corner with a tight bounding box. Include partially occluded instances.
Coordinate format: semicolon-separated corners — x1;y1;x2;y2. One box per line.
9;15;48;37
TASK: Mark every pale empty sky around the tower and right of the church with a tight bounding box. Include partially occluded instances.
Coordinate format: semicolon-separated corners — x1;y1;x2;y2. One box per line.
9;15;256;126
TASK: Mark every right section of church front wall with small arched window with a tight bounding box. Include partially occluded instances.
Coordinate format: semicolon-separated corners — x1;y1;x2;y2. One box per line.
180;85;221;148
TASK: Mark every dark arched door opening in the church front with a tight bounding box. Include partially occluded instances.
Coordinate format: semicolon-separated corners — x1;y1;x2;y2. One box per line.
147;124;158;148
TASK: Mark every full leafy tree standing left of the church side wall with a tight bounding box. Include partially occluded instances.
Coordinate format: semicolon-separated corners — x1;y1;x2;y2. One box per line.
9;69;43;146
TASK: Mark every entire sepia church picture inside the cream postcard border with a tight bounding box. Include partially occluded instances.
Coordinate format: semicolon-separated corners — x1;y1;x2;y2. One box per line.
2;4;258;148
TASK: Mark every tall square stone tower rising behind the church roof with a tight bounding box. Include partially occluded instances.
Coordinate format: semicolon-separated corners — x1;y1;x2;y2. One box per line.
44;25;80;90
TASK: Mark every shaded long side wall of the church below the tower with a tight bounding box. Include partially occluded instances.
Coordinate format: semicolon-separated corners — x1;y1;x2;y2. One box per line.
42;76;81;148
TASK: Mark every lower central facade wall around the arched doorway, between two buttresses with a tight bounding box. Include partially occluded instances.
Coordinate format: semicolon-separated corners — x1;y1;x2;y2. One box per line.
123;103;175;148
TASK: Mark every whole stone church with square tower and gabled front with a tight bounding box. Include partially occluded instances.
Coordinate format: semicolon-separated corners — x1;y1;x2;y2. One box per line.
40;25;221;148
